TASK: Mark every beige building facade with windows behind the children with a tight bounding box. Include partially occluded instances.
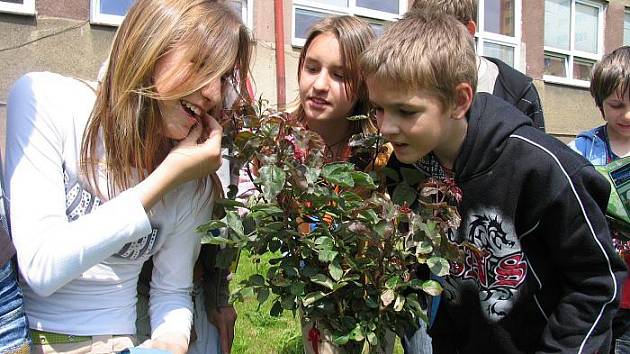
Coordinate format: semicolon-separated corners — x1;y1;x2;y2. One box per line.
0;0;630;146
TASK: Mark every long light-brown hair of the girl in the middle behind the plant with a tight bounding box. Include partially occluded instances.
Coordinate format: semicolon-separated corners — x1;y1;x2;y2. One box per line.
289;16;376;133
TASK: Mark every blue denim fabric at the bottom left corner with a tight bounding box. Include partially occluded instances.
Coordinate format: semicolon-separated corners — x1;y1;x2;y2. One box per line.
0;261;30;353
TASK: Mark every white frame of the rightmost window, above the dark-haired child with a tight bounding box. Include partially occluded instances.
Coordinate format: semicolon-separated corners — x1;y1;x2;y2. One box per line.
543;0;607;88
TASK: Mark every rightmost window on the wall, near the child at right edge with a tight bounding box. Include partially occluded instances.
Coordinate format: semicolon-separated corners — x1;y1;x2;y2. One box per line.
543;0;604;87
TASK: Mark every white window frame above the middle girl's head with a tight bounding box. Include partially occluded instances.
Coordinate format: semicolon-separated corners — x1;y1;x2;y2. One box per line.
291;0;412;47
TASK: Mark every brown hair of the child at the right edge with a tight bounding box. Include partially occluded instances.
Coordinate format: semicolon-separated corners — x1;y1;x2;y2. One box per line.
590;46;630;118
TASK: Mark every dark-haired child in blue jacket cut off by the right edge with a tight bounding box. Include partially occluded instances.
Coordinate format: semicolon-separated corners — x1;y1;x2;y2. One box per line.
569;46;630;353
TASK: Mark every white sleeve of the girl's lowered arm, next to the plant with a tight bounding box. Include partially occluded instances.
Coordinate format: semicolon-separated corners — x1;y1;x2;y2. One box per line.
150;178;213;340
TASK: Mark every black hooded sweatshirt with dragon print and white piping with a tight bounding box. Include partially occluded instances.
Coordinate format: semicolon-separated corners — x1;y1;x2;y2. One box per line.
430;93;626;354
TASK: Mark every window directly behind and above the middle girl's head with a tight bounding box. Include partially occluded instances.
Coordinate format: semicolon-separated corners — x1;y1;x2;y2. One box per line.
292;0;407;46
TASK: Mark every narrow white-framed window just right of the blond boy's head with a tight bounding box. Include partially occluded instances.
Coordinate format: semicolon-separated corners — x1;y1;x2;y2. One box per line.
475;0;521;69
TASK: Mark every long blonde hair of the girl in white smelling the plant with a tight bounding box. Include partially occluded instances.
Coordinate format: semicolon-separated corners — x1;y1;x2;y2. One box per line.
81;0;252;194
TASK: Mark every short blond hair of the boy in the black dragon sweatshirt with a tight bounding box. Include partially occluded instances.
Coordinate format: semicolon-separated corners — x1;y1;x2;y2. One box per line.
361;10;477;110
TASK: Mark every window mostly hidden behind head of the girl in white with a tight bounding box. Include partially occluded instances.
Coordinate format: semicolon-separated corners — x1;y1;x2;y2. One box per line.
90;0;253;28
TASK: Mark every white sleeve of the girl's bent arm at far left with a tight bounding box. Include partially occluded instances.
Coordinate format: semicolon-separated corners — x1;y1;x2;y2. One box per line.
5;73;151;296
